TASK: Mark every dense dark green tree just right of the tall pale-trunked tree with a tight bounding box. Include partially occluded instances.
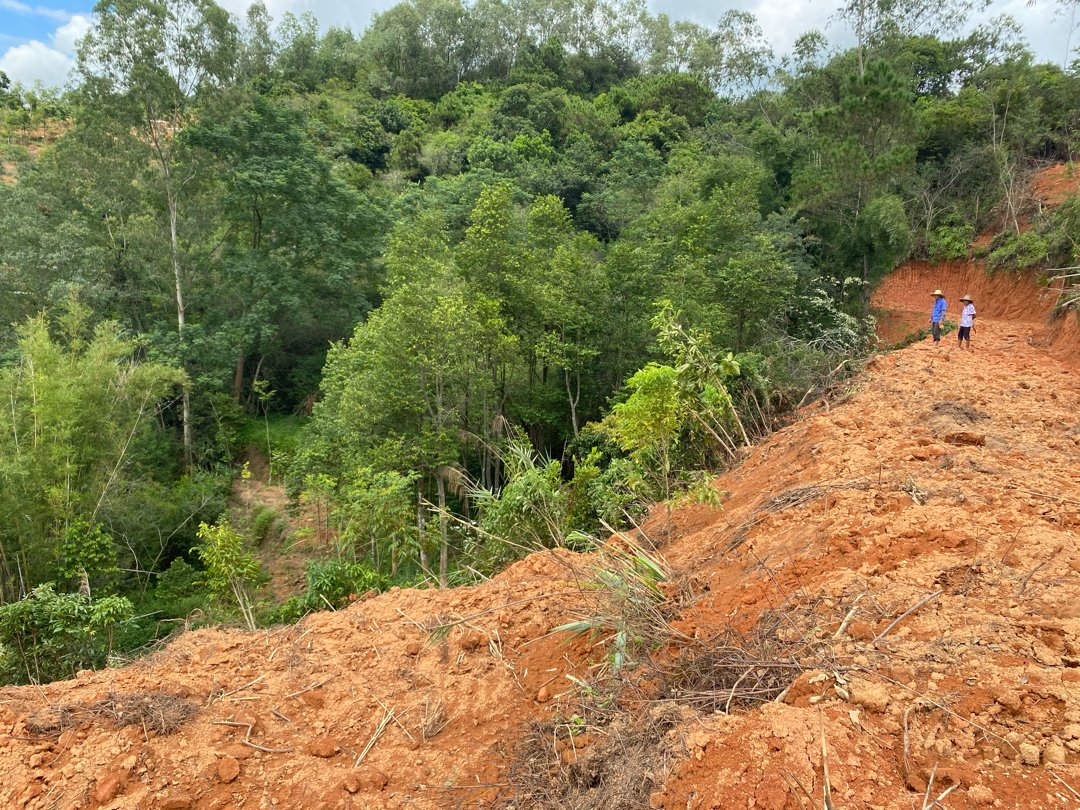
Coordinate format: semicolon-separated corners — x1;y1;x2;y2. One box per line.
185;95;384;403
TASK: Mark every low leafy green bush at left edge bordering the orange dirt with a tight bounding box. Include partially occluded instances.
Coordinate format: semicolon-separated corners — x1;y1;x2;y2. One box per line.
0;582;134;684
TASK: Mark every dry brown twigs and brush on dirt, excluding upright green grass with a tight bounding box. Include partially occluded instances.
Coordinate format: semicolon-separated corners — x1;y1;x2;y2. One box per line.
500;609;835;810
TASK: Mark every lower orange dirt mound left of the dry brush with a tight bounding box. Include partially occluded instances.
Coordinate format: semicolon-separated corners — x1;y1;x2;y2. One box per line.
0;554;589;808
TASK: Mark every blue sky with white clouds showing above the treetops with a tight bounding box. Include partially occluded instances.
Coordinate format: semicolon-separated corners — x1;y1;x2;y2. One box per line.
0;0;1080;85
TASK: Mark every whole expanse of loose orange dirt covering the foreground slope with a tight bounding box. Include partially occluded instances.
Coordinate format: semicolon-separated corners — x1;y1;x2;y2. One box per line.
0;328;1080;810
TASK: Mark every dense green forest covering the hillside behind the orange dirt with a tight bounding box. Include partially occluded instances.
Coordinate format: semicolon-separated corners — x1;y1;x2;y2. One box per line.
0;0;1080;683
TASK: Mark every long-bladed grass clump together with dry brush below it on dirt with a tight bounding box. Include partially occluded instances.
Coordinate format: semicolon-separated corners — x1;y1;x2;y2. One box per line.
500;533;834;810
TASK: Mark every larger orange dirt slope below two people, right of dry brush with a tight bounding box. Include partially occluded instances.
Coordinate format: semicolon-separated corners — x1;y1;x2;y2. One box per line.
653;321;1080;808
